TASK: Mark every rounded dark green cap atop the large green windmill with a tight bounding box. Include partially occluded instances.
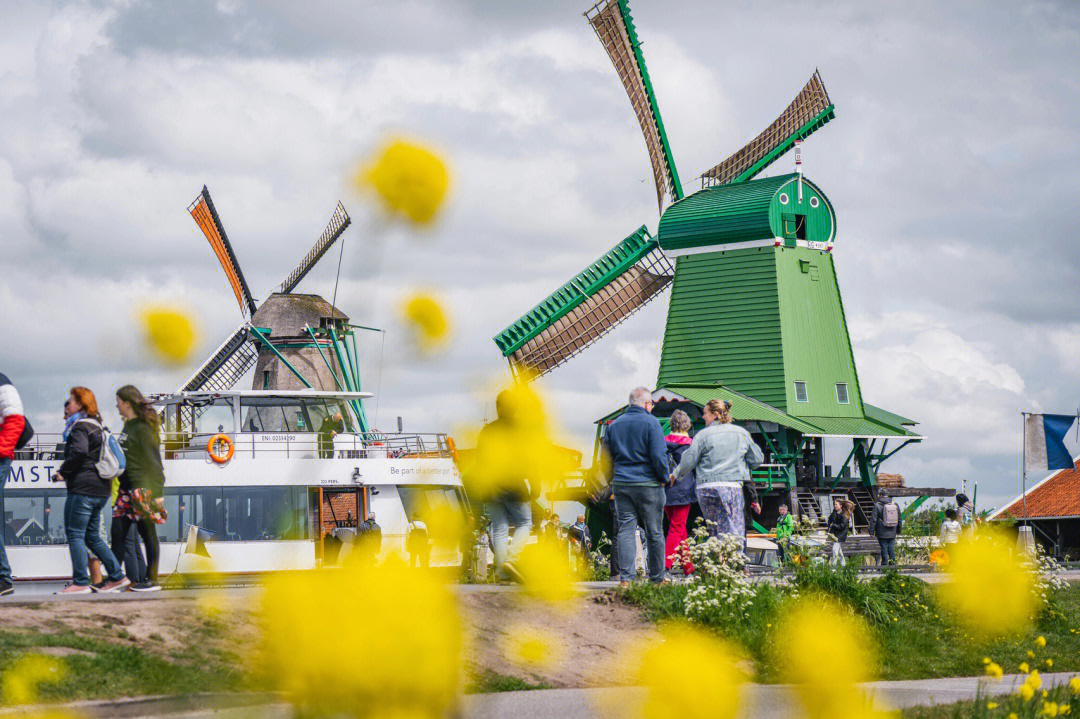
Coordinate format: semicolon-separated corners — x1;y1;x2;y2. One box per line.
657;174;836;250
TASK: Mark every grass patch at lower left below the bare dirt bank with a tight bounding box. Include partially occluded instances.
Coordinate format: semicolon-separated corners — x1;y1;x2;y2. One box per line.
0;630;242;702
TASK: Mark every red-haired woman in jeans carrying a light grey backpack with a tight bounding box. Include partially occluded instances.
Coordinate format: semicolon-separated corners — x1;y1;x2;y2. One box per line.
53;386;131;594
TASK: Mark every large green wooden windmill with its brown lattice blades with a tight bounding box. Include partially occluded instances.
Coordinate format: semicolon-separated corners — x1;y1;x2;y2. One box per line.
495;0;944;526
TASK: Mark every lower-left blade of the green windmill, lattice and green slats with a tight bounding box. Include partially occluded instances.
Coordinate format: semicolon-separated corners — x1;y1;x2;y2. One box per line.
495;226;674;377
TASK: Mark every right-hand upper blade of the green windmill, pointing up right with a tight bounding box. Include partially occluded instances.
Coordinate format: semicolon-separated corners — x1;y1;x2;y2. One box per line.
701;70;836;187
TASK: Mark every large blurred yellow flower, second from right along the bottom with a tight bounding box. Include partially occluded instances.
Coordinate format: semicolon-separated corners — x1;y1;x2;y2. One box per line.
780;600;877;719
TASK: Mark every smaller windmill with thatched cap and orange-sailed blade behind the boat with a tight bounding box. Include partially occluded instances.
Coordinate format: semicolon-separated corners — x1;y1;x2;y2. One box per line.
179;186;368;432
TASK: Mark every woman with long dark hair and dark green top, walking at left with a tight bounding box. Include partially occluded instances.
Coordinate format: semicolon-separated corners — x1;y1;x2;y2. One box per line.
112;384;168;592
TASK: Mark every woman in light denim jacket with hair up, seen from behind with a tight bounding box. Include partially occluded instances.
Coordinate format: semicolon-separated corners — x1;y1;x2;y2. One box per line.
672;399;765;547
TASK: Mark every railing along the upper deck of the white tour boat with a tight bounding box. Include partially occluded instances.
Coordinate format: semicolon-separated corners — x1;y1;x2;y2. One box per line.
15;430;454;462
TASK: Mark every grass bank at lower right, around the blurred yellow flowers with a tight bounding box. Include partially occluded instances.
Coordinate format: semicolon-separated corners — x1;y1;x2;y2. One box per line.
621;569;1080;682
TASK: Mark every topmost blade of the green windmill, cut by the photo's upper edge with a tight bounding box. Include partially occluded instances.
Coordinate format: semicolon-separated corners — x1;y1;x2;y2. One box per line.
585;0;683;213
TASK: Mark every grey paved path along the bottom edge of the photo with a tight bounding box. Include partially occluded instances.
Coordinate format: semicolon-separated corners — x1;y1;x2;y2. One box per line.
10;673;1077;719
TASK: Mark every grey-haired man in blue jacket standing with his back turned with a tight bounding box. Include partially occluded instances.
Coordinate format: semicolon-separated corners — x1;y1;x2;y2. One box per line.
604;386;669;586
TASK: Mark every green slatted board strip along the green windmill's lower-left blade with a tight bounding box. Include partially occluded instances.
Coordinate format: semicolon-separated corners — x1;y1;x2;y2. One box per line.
495;225;657;357
